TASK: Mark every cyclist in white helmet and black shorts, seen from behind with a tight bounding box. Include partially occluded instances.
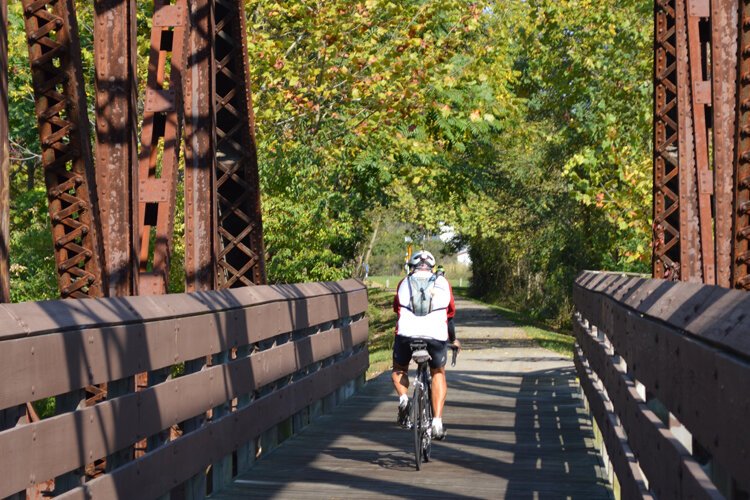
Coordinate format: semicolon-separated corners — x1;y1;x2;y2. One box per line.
391;250;461;439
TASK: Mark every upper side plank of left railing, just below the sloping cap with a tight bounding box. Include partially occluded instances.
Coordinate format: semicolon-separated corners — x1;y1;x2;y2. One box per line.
0;292;367;409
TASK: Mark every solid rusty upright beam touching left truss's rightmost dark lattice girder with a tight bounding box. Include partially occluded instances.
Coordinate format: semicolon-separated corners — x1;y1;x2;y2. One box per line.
183;0;216;292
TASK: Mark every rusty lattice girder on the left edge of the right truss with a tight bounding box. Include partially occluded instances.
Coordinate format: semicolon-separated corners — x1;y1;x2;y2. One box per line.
653;0;680;279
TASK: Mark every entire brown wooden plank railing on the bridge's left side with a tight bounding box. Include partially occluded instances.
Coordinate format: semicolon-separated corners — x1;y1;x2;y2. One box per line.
0;280;368;498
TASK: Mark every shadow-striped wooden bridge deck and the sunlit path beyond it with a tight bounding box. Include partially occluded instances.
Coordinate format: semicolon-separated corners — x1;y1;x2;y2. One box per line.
213;301;611;499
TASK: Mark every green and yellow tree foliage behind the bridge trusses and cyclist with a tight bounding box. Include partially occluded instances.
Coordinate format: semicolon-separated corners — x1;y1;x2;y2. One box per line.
2;0;653;323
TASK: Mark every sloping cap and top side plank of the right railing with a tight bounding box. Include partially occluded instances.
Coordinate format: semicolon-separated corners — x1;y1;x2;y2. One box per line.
574;273;750;490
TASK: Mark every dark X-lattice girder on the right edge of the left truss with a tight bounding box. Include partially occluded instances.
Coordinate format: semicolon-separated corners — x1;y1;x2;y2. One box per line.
214;0;266;288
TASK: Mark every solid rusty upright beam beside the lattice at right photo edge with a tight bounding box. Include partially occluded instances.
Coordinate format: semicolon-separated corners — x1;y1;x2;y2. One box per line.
711;0;738;287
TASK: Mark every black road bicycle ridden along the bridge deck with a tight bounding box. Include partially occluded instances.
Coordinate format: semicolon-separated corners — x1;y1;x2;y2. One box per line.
410;340;458;470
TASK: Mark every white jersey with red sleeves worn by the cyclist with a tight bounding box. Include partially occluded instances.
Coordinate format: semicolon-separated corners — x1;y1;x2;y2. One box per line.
393;271;456;341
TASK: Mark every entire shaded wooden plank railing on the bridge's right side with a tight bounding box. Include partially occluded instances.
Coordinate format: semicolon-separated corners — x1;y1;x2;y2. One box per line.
573;272;750;498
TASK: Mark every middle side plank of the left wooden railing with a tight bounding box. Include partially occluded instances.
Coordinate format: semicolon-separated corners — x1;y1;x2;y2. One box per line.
0;319;368;497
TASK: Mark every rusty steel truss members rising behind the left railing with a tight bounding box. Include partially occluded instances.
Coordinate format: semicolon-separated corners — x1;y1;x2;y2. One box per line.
0;0;266;302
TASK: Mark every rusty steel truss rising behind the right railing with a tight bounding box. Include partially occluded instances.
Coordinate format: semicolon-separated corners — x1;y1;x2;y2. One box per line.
653;0;750;289
